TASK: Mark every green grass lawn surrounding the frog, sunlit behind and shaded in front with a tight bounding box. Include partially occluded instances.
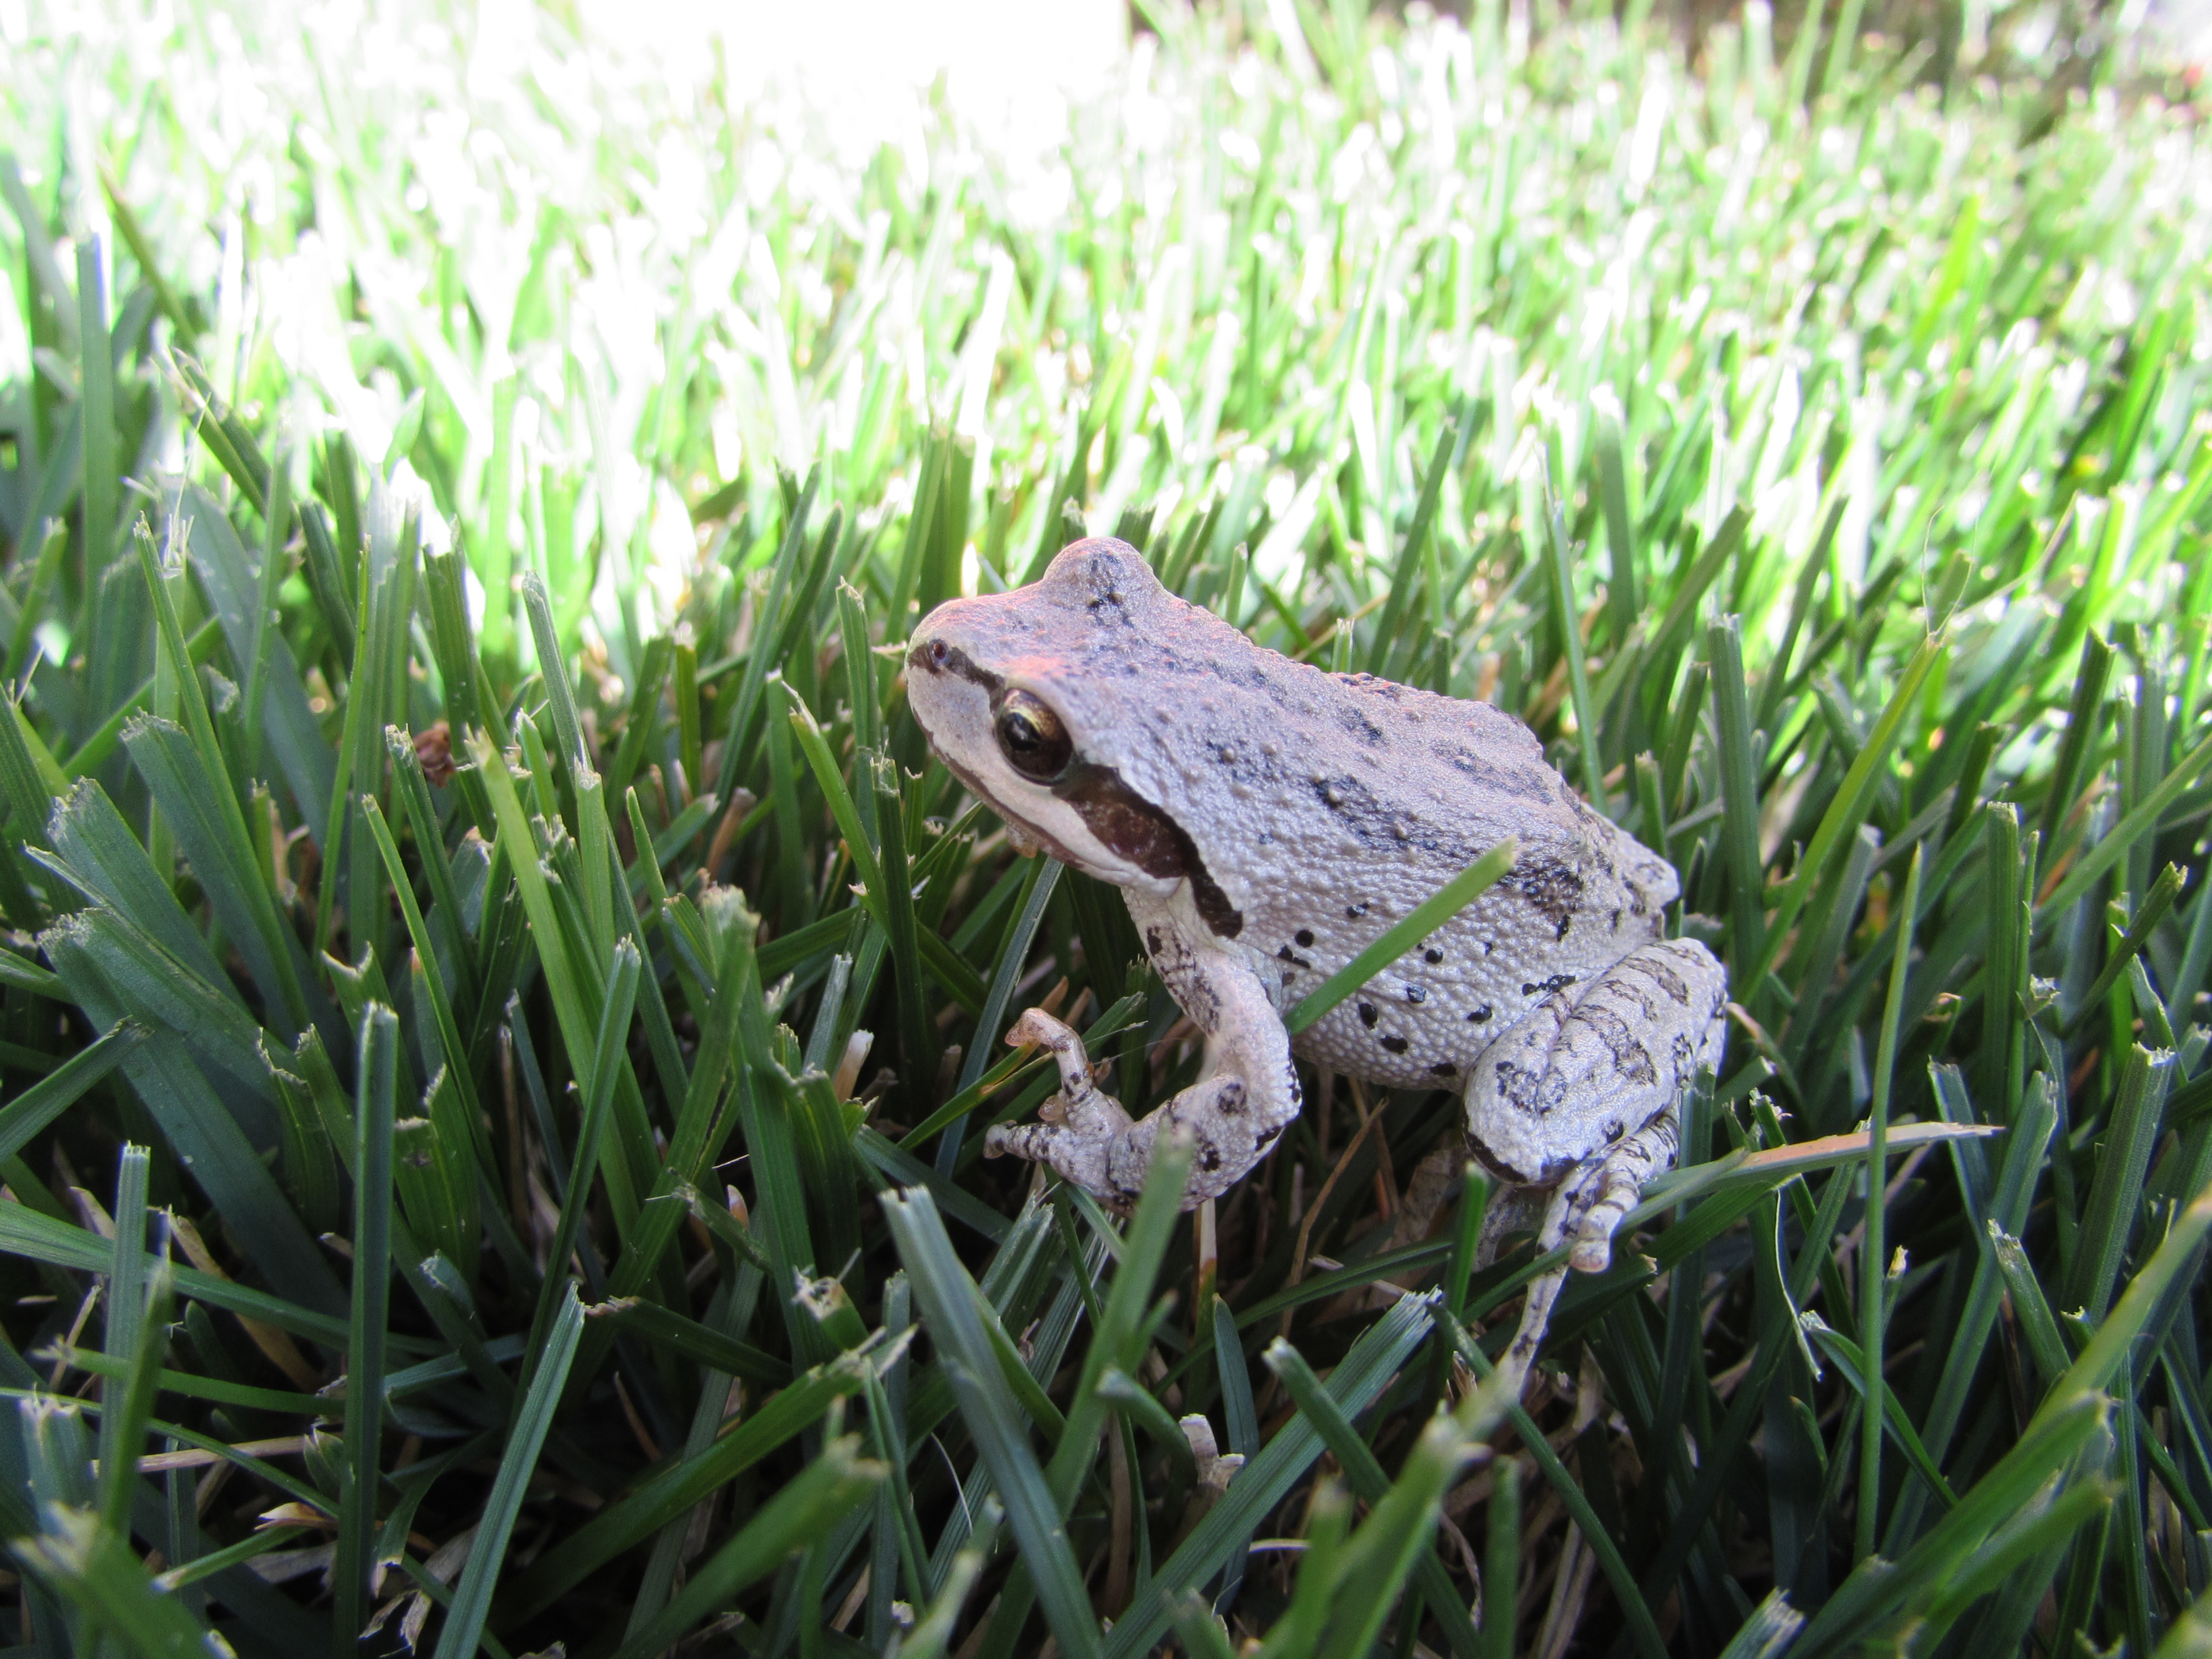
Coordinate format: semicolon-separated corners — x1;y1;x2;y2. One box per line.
0;4;2212;1659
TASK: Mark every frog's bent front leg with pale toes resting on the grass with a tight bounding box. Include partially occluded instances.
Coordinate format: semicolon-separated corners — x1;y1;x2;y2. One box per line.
982;905;1298;1210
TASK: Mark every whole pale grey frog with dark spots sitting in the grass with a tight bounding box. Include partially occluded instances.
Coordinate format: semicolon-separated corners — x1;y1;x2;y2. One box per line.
907;540;1728;1376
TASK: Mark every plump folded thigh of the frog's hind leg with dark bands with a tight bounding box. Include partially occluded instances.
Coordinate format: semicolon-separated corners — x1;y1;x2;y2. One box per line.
1467;940;1728;1272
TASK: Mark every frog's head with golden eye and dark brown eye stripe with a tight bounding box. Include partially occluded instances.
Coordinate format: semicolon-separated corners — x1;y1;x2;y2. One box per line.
907;538;1252;933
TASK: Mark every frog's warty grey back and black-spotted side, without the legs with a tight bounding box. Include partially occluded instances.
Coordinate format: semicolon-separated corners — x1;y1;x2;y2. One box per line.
1009;542;1677;1086
